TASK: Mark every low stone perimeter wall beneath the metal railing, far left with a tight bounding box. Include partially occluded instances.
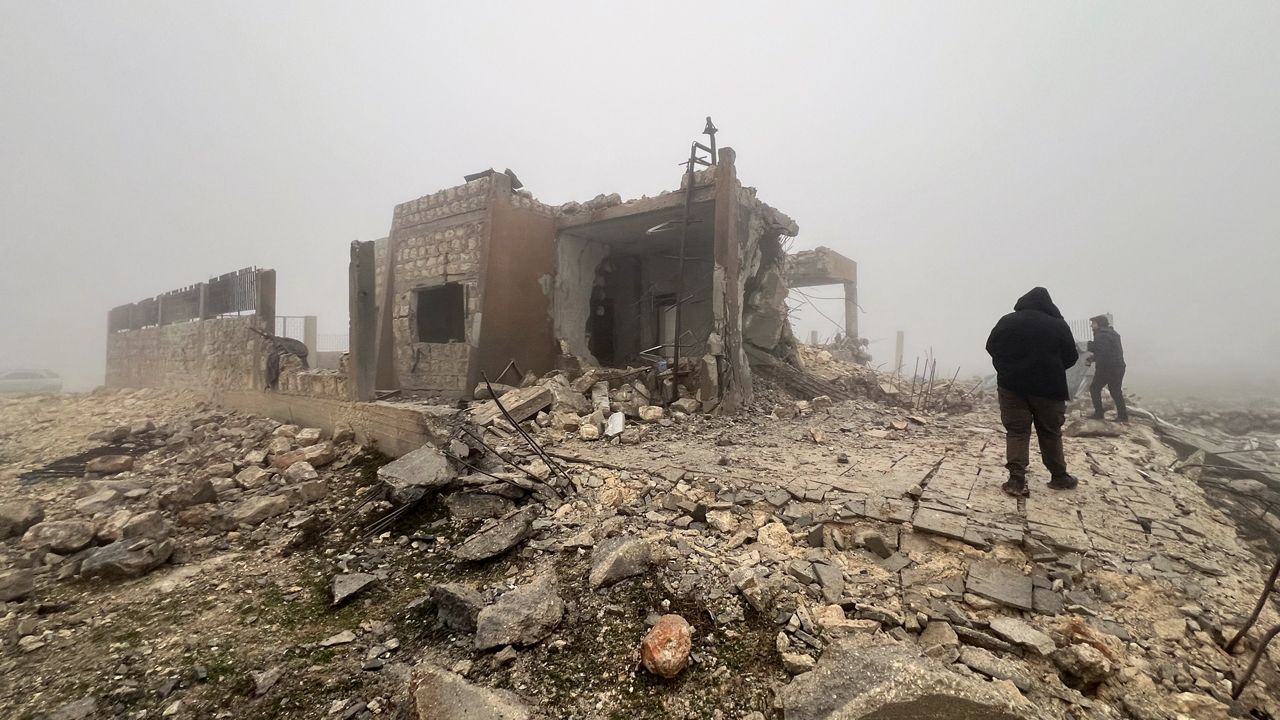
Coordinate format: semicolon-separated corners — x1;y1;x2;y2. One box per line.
106;315;269;389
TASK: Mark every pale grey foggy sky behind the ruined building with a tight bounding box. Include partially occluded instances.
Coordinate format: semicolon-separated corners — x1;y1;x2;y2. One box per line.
0;0;1280;393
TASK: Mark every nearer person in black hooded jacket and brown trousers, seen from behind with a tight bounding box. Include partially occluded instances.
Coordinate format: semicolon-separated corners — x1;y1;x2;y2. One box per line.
987;287;1080;497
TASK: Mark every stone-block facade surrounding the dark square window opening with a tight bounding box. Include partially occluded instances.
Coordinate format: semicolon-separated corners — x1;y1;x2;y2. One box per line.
390;177;493;397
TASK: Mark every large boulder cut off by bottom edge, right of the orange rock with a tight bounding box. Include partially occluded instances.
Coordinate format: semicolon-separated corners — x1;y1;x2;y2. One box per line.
782;641;1043;720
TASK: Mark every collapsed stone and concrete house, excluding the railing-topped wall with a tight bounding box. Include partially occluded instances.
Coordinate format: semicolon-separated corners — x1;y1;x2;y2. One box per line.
366;149;856;413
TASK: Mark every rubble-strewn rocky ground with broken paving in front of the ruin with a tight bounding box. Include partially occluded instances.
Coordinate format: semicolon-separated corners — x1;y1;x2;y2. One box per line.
0;375;1280;720
